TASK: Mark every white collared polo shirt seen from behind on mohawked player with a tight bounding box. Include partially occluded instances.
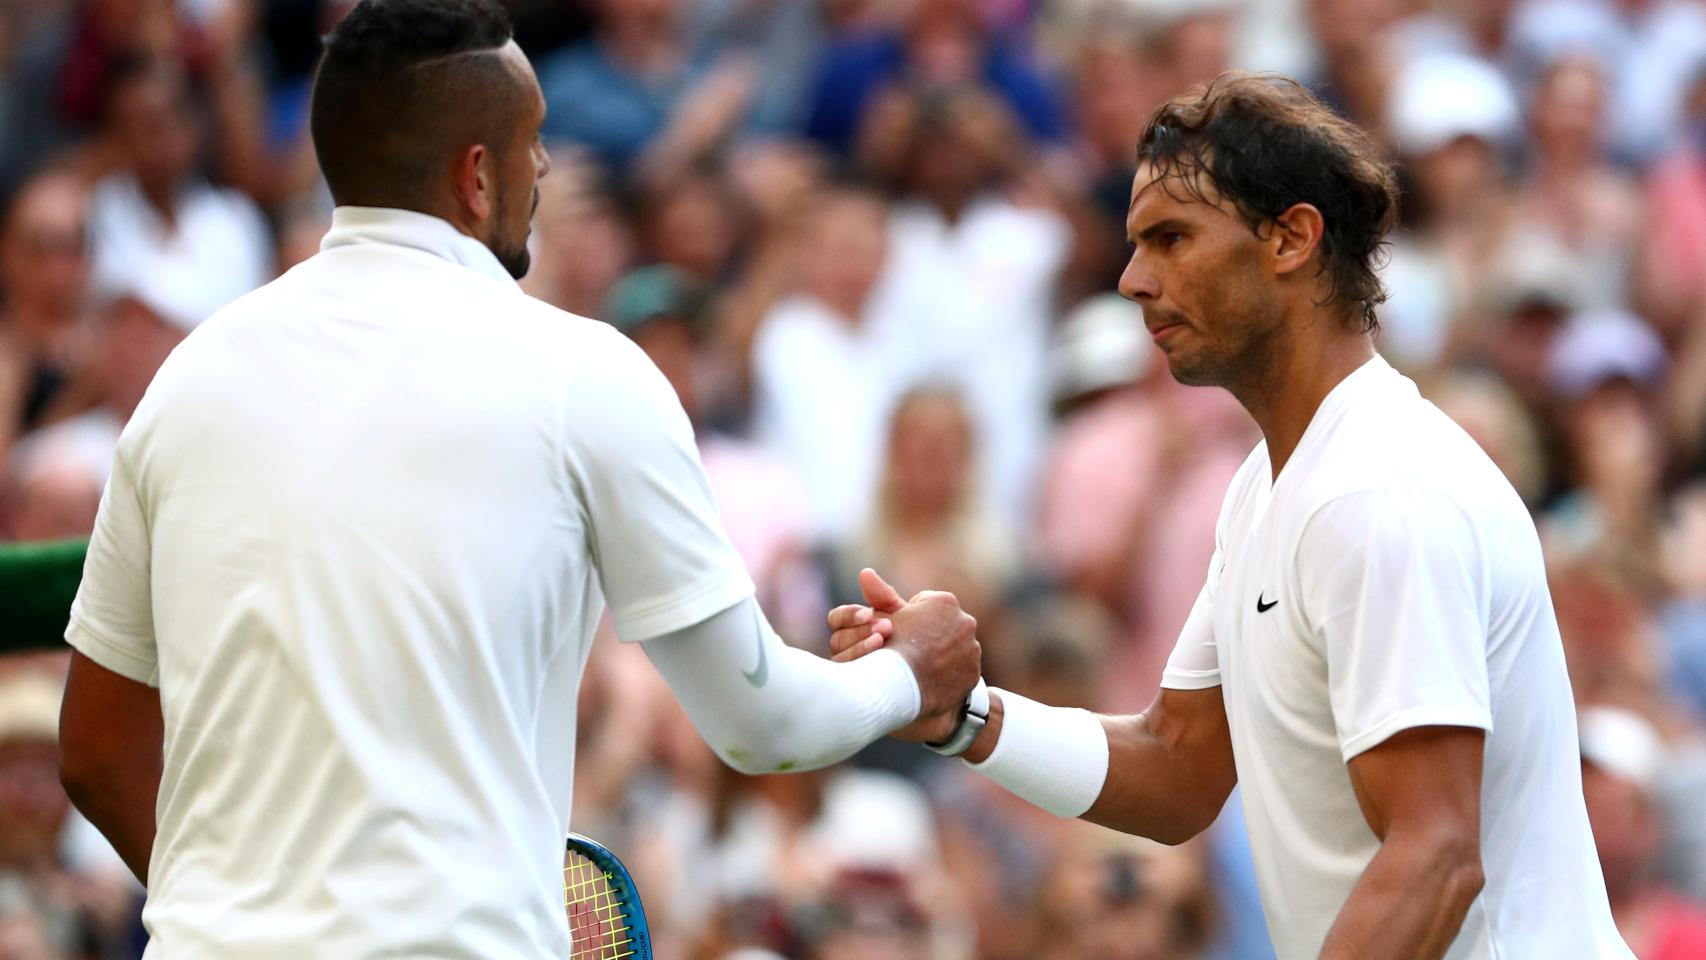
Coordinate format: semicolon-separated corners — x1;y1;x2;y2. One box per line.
67;208;752;960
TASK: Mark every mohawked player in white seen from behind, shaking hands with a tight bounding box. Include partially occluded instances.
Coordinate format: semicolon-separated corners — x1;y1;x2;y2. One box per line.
61;0;979;960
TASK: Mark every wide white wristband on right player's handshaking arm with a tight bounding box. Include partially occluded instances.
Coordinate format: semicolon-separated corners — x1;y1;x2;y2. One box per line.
966;691;1107;818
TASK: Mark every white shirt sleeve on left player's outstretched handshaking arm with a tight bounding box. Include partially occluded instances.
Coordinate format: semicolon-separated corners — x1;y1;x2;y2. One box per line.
563;329;754;643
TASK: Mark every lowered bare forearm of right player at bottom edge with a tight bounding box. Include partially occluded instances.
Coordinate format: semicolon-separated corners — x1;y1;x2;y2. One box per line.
1320;836;1483;960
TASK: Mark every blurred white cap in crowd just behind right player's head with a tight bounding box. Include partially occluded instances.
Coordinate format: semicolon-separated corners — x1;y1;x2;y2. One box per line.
1387;53;1520;157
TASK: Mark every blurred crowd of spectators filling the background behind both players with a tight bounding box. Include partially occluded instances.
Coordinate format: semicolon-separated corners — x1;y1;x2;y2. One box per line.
0;0;1706;960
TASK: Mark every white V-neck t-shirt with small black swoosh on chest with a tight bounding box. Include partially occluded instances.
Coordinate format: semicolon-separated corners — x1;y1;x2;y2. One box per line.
1162;358;1633;960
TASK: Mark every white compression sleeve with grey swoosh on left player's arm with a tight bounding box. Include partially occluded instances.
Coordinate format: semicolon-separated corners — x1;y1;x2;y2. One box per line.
640;597;920;774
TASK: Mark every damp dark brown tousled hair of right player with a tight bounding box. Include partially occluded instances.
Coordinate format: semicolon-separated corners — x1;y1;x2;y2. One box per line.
1138;72;1397;331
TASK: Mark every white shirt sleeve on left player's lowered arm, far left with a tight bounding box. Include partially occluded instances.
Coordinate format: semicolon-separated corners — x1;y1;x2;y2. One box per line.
65;447;160;687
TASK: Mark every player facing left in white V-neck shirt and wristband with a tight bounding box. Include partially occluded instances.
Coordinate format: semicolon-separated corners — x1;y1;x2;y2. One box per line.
831;75;1633;960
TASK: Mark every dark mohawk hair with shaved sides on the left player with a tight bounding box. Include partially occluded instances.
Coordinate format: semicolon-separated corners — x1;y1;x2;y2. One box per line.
309;0;520;208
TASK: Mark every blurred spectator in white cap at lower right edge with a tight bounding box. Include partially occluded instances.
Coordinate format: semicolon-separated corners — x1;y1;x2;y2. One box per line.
1580;706;1706;960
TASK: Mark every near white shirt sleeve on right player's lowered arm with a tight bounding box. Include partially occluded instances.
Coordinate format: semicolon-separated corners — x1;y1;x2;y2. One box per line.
1297;489;1493;760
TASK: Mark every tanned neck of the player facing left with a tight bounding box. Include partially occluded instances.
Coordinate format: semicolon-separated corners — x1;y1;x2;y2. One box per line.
1232;307;1375;479
